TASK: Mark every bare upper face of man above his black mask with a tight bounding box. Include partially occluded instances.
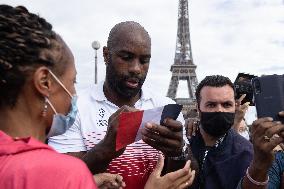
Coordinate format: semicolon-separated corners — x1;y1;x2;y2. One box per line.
199;85;235;113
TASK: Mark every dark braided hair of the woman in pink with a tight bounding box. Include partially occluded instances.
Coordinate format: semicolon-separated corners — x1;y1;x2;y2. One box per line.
0;5;65;107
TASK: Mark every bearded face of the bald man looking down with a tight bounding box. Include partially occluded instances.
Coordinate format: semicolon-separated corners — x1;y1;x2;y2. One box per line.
104;32;151;99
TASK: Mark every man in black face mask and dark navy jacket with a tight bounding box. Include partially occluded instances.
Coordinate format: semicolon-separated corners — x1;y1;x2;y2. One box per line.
190;75;253;189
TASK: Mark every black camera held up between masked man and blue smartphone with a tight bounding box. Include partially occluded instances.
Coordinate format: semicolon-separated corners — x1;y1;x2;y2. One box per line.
234;73;256;106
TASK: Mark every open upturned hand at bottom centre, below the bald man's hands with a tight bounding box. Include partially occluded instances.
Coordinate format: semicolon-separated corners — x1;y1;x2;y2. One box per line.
144;155;195;189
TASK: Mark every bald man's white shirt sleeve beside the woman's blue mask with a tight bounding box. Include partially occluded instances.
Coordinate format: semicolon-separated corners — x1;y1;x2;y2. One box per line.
48;112;87;153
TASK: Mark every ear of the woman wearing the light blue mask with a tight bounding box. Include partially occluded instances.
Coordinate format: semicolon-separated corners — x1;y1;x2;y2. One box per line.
33;66;52;97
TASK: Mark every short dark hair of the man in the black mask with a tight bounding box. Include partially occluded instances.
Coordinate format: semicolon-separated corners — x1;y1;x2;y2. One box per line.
195;75;235;107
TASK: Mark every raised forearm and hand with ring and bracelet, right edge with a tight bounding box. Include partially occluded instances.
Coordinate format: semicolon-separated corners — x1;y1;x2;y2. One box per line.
242;112;284;189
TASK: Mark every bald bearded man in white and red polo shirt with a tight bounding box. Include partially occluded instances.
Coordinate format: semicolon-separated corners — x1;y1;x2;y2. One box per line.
49;21;183;189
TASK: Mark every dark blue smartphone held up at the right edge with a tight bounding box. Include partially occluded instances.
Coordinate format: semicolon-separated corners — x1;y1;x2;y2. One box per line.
252;75;284;123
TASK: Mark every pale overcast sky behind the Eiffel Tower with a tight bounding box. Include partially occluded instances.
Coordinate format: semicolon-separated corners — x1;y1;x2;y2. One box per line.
0;0;284;122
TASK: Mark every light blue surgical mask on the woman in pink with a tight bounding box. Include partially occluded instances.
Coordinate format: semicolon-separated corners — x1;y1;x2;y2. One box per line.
46;71;78;138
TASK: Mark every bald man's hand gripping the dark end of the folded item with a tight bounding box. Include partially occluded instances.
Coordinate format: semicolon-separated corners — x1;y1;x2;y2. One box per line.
142;118;183;156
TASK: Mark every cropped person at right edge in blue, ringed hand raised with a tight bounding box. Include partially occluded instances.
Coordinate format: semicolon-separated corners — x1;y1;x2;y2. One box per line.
238;111;284;189
